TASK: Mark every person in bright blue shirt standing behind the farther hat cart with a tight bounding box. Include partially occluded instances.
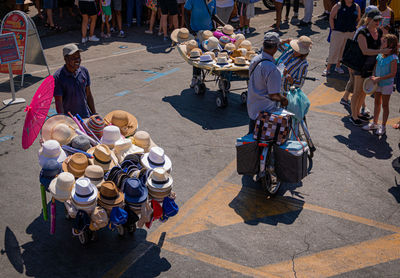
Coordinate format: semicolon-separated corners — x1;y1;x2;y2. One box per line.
185;0;225;88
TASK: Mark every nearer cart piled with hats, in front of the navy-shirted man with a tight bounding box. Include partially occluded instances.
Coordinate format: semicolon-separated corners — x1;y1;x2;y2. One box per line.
38;110;179;244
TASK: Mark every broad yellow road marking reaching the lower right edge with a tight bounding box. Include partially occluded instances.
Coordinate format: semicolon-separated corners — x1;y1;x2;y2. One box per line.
257;234;400;278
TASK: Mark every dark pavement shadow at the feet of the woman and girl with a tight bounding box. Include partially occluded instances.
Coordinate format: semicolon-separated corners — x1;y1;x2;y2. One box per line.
334;117;393;159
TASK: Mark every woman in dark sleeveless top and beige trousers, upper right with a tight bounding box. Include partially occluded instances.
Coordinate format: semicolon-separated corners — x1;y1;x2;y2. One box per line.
322;0;361;76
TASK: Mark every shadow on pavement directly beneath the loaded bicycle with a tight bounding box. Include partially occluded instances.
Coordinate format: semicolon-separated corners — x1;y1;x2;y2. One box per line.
229;175;304;226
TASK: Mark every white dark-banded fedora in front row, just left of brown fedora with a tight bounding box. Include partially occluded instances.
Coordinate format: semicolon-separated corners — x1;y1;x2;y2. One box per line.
71;178;98;210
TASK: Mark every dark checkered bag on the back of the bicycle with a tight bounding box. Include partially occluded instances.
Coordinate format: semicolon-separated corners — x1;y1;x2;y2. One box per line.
253;112;292;145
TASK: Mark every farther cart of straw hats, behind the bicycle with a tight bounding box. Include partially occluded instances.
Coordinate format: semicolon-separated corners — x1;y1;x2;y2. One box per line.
171;25;257;108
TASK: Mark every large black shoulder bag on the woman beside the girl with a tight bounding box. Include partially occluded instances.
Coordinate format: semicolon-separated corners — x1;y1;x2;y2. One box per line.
340;33;366;71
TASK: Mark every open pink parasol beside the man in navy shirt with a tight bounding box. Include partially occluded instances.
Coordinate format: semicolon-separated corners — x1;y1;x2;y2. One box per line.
22;75;54;149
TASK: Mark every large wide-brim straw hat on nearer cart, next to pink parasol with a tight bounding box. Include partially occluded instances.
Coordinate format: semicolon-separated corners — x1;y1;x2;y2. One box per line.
41;115;78;145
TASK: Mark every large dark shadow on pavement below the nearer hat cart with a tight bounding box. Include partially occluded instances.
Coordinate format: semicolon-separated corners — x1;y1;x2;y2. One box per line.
2;202;171;277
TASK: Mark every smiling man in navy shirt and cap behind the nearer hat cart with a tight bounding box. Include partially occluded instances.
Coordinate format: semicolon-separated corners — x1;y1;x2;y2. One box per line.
53;44;96;118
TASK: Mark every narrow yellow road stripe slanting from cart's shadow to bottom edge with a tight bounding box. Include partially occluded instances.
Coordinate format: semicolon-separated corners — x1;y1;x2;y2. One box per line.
163;241;278;278
